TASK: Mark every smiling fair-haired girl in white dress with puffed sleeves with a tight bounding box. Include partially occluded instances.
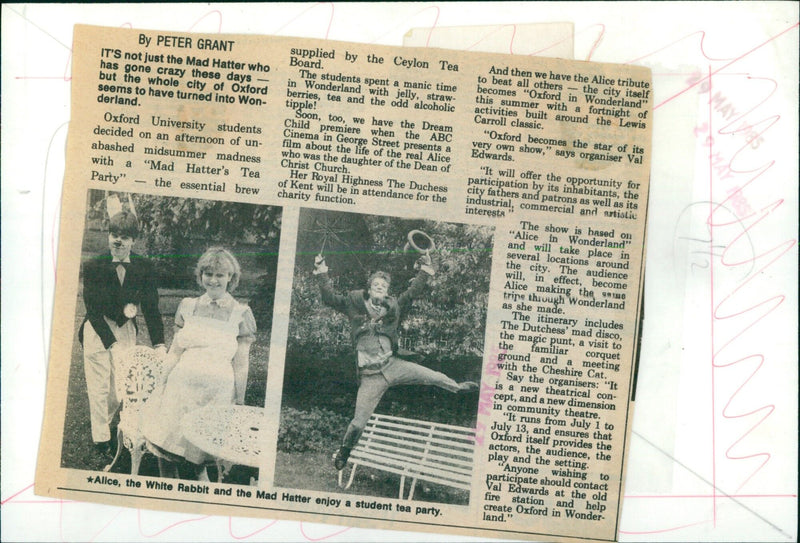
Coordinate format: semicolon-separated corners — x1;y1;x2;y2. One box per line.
142;247;256;478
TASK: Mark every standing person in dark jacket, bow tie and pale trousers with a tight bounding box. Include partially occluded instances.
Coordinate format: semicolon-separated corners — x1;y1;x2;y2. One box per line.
78;210;166;454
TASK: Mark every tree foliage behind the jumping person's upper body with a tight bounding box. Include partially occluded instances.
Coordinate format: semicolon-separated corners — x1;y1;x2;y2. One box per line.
288;210;493;357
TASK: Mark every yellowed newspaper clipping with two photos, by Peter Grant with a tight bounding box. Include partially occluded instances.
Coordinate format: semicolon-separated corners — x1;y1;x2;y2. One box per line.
35;26;652;541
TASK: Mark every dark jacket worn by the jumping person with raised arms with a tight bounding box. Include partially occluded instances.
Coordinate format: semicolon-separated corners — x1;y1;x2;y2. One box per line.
317;271;430;351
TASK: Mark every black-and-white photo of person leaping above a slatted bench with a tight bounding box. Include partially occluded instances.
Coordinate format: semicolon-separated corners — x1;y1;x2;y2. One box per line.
275;209;494;505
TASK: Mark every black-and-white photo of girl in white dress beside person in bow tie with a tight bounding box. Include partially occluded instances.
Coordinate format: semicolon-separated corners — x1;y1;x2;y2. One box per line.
61;190;282;484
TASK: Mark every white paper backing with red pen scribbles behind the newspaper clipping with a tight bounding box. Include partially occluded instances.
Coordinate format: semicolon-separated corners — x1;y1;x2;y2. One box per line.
0;2;798;541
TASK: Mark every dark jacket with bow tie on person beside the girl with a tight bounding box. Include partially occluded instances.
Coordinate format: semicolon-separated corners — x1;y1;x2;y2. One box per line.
78;254;164;349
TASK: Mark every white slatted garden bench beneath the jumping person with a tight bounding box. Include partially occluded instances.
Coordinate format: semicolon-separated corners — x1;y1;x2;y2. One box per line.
339;414;475;500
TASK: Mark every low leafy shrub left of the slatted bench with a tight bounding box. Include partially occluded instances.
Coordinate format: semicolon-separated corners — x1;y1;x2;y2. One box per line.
278;407;349;452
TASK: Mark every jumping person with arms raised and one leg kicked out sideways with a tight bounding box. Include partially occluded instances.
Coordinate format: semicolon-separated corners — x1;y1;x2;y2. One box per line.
314;253;478;470
